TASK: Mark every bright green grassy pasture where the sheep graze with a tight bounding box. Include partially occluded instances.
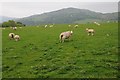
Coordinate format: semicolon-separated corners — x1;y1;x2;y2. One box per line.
2;23;118;78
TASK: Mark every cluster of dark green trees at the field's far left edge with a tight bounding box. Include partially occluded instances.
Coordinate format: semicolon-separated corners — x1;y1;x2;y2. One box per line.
2;20;25;27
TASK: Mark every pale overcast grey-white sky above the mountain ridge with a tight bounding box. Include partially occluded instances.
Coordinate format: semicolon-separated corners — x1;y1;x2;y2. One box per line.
0;0;118;18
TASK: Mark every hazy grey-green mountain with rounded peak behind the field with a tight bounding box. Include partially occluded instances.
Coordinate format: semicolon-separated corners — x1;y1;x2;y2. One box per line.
16;8;118;25
